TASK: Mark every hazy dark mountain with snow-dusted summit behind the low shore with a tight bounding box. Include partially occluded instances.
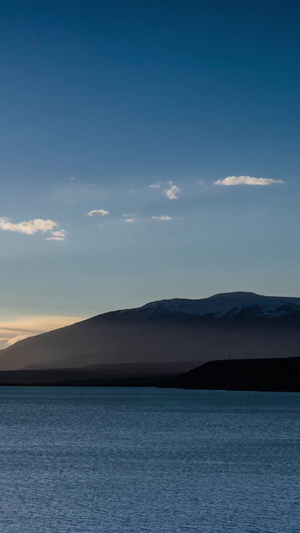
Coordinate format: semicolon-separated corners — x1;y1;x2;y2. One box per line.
0;292;300;376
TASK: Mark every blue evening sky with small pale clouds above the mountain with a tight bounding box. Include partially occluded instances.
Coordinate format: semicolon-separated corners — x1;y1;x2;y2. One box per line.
0;0;300;348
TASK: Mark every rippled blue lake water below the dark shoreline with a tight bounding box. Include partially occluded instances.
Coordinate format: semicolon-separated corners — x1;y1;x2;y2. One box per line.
0;387;300;533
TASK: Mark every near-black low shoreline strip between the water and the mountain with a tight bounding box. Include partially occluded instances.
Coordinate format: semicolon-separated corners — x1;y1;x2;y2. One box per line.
0;357;300;392
